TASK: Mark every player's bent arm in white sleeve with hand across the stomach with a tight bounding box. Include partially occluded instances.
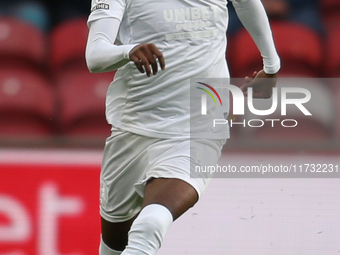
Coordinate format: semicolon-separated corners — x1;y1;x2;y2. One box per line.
85;18;165;76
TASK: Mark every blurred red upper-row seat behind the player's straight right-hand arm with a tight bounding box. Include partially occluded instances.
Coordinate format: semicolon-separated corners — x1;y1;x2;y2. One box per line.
228;22;322;77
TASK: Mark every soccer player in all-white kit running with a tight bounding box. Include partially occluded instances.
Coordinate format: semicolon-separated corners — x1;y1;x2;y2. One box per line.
86;0;280;255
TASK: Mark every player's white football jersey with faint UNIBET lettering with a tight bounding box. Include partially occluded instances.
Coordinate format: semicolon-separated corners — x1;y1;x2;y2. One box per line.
89;0;229;139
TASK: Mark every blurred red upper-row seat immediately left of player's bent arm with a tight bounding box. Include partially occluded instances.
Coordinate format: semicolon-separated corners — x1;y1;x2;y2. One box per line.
50;18;88;72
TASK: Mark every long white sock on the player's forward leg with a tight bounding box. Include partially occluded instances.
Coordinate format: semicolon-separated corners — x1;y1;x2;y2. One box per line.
121;204;173;255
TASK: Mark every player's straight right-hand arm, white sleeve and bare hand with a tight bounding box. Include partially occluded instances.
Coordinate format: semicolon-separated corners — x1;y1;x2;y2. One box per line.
232;0;281;98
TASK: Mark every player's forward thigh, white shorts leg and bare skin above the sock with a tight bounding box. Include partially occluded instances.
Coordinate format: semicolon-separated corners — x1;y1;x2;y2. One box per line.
143;139;225;219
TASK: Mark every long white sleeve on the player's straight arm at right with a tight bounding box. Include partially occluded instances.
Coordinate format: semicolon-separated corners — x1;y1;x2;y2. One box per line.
230;0;281;74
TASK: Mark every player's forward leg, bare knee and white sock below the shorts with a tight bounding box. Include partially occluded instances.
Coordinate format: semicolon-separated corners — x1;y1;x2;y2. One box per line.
122;178;198;255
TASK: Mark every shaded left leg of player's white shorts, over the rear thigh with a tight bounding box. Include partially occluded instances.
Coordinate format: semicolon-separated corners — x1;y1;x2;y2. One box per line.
100;129;154;226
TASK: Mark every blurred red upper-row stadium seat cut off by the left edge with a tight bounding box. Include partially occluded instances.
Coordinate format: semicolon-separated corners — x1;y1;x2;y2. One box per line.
0;17;46;67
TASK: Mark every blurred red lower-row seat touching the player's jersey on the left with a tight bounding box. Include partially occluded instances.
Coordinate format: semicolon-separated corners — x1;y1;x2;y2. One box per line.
56;69;113;139
